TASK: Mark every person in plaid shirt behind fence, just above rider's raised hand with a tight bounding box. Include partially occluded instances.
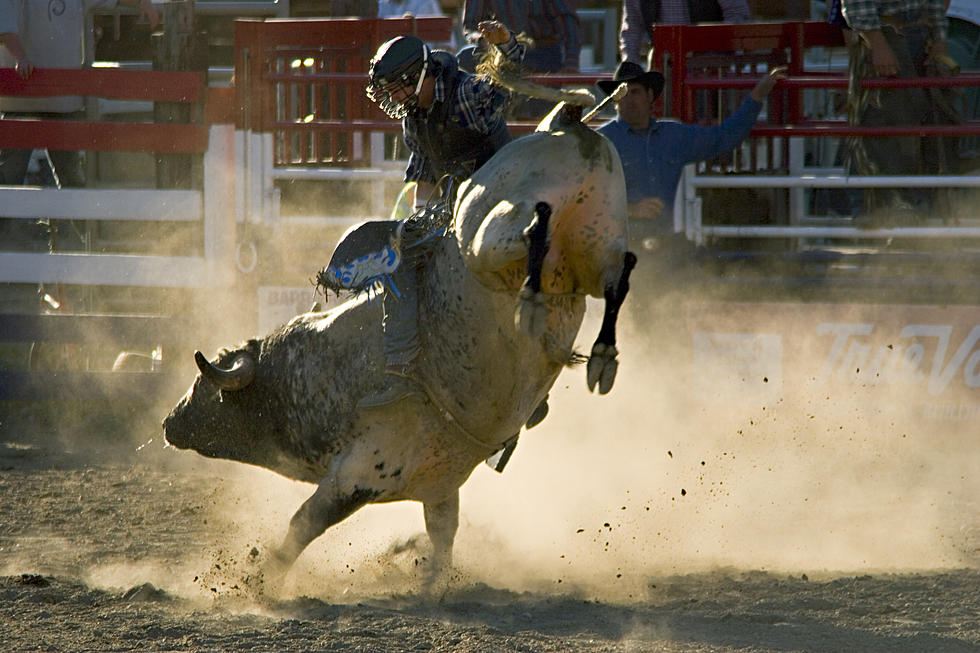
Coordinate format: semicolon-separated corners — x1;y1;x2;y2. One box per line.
463;0;582;73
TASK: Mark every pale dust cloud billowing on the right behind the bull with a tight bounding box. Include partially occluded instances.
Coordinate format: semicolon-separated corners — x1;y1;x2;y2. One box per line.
458;298;980;596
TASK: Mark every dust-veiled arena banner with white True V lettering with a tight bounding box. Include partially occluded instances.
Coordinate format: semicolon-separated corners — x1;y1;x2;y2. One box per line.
686;302;980;420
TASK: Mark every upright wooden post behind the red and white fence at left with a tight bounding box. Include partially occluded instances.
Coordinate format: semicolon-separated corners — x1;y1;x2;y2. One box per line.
153;0;208;188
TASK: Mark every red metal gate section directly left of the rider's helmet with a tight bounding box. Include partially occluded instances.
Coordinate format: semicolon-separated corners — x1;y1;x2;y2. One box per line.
235;17;452;168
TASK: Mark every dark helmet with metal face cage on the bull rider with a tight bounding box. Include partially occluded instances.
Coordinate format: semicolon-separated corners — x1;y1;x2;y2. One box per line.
367;36;429;120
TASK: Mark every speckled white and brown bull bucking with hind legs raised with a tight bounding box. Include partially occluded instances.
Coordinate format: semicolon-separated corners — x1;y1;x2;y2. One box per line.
163;104;636;584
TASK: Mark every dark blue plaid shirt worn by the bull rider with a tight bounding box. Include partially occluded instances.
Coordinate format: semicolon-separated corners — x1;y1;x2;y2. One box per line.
403;36;527;181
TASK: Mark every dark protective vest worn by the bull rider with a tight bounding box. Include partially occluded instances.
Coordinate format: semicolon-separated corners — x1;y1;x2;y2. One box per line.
404;51;510;182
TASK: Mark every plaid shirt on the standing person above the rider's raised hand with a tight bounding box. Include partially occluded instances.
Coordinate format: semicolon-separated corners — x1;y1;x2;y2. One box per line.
463;0;582;70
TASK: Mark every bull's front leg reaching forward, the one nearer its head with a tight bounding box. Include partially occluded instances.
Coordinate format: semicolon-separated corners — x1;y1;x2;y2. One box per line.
262;476;380;584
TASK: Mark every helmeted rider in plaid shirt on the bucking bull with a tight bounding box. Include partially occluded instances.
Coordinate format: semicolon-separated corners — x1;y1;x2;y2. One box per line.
352;21;525;408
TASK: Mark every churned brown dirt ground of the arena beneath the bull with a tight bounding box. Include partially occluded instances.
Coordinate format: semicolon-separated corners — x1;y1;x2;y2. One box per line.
0;398;980;653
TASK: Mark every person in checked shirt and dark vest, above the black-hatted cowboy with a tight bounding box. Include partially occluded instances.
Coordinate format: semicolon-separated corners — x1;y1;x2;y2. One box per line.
619;0;751;65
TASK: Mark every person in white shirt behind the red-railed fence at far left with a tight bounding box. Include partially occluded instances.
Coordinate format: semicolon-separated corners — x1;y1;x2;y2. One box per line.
0;0;159;186
